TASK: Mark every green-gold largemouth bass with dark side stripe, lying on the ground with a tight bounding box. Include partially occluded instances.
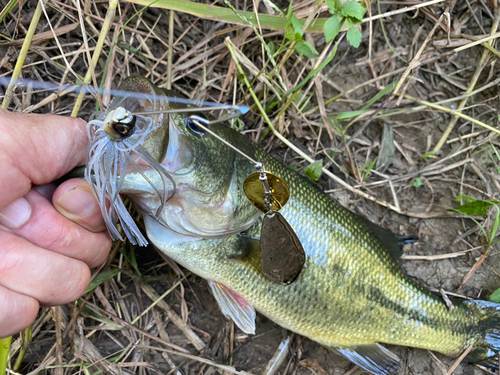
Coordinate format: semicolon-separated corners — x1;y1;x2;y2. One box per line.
91;76;500;374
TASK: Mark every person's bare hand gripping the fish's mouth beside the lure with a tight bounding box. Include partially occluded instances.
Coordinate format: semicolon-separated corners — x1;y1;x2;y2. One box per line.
0;110;111;338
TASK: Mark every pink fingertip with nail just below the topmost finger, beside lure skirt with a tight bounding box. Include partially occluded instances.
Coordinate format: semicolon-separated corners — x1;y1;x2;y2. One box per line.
52;178;106;232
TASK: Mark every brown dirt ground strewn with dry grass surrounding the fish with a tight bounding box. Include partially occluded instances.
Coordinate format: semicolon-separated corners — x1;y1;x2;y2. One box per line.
0;0;500;375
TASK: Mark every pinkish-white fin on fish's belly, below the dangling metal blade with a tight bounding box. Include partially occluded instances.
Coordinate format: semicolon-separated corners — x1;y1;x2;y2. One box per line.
207;280;255;335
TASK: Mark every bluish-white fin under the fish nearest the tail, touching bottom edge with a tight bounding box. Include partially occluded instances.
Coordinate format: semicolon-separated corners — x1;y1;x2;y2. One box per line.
332;344;399;375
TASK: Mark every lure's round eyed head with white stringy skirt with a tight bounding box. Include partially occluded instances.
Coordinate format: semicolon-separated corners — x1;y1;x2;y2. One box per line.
85;107;175;246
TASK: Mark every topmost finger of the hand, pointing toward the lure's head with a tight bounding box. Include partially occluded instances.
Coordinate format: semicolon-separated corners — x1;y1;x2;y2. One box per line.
0;110;88;211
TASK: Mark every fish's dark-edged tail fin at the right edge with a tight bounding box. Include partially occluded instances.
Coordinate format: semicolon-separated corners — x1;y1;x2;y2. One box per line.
464;300;500;370
